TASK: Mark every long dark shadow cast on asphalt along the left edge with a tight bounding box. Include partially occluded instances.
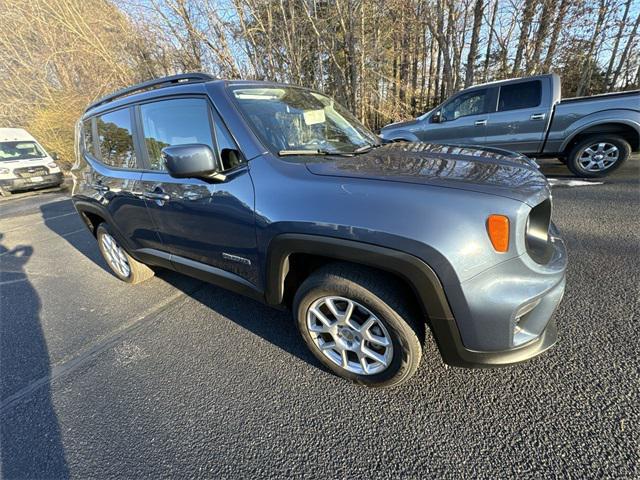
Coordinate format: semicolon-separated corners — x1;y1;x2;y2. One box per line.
0;233;69;478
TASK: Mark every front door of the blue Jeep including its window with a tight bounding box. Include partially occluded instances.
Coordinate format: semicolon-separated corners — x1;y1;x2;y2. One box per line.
137;96;258;284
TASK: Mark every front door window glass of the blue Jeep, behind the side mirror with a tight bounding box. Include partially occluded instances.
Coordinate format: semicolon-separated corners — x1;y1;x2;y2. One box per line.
140;98;214;170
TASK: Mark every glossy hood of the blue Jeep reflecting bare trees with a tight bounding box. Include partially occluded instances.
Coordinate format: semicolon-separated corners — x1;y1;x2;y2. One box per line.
305;142;550;206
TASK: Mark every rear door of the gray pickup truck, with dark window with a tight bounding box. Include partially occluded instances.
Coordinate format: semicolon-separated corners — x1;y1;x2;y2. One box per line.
485;80;551;153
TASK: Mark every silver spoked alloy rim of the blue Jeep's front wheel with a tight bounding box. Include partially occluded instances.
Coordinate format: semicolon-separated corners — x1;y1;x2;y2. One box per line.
306;296;393;375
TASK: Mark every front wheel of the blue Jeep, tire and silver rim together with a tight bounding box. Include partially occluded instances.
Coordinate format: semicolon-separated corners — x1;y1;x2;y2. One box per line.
293;264;422;387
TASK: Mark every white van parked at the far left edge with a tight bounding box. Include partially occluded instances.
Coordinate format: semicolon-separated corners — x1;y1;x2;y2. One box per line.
0;128;64;194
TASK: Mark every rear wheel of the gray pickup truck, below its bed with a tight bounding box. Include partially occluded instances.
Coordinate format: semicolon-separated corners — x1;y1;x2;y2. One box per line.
567;135;631;178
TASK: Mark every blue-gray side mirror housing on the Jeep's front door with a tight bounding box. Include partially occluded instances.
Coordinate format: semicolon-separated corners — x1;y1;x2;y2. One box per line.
162;143;220;179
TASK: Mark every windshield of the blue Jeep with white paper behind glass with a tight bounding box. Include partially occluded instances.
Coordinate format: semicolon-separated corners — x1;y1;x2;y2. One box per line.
232;87;378;153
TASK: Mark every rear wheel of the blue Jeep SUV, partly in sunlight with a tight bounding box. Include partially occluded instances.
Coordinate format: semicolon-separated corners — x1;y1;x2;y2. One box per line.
96;223;155;284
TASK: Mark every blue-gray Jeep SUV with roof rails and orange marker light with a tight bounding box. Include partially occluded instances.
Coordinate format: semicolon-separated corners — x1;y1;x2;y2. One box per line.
73;74;567;386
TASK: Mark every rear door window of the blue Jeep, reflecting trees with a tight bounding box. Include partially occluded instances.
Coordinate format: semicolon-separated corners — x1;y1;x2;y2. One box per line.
96;108;136;168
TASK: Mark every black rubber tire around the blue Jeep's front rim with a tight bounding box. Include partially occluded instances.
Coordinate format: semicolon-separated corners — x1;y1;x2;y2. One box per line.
293;263;425;387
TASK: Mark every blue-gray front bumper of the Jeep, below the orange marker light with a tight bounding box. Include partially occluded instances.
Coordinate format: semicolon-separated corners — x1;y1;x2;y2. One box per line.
435;227;567;367
